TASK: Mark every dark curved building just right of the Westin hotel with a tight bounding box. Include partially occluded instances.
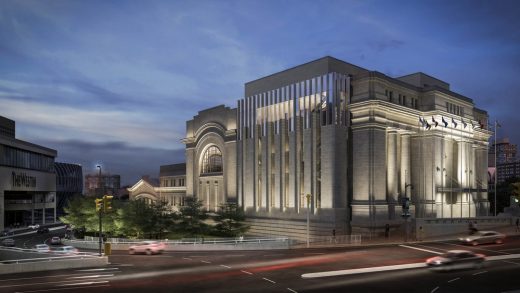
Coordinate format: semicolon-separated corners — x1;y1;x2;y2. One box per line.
54;162;83;218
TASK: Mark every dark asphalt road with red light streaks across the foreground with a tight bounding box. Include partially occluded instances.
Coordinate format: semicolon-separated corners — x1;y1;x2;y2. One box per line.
0;236;520;293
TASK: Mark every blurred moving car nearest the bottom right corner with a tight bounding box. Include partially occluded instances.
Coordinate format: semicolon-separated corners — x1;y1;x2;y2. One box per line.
426;250;486;271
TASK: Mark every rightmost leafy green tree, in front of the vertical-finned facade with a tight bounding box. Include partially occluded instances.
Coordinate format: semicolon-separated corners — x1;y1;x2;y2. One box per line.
215;203;249;237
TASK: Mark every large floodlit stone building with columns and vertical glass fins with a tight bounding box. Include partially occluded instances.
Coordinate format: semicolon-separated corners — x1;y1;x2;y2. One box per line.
178;57;491;238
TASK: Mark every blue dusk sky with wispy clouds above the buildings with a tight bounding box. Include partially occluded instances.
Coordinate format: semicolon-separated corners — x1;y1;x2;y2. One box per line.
0;0;520;184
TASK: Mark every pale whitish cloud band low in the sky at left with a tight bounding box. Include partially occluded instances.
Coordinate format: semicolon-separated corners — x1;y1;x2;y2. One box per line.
0;98;185;148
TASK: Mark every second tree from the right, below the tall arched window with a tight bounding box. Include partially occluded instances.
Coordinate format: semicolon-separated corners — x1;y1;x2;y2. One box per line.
179;197;208;236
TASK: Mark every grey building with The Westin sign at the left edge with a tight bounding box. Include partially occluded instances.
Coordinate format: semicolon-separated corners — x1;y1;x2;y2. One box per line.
0;116;57;230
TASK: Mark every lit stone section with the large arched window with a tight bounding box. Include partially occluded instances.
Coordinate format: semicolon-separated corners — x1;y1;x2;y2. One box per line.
183;106;237;211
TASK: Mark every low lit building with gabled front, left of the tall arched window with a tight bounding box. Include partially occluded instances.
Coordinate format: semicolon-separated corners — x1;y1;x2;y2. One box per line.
128;163;186;211
